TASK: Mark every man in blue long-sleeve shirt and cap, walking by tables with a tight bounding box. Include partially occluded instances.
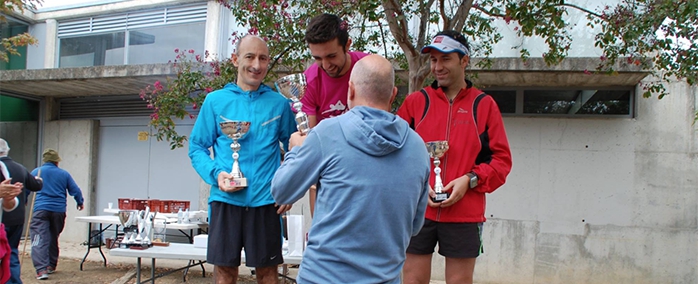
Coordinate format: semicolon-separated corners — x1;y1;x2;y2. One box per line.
29;148;85;280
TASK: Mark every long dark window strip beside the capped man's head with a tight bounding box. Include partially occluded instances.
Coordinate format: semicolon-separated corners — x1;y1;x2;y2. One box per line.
485;87;634;117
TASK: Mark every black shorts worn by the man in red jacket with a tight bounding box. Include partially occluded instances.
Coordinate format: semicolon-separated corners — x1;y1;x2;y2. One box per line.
407;219;485;258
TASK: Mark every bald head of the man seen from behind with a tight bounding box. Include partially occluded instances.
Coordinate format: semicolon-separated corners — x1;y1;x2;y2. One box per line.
349;55;397;110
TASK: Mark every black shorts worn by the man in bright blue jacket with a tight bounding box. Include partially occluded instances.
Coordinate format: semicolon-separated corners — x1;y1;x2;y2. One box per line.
206;202;284;267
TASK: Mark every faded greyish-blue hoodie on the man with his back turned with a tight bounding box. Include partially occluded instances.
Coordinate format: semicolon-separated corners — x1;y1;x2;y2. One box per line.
271;106;430;283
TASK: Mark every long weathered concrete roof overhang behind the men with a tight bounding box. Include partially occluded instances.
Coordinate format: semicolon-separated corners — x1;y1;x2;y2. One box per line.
0;58;649;98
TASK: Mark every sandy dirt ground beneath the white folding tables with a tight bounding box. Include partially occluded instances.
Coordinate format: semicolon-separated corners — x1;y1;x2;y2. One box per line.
22;255;284;284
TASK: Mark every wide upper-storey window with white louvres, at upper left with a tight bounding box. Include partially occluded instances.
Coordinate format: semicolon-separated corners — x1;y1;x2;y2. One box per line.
58;5;206;67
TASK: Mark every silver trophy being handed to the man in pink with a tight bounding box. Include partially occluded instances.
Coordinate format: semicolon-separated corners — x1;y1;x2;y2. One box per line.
274;73;310;135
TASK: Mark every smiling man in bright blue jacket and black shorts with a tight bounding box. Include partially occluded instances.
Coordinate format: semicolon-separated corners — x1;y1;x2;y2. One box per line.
189;35;296;283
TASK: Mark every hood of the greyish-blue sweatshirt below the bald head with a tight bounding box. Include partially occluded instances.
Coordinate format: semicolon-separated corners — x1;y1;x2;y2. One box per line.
341;106;409;156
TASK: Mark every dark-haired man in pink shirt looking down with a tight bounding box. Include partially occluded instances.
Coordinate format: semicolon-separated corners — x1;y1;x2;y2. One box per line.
301;14;368;215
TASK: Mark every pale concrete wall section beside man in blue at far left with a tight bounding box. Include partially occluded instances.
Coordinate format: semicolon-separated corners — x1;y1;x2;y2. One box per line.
42;120;101;242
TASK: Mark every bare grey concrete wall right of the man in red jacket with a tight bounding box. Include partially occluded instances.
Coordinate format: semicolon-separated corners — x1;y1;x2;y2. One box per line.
432;79;698;283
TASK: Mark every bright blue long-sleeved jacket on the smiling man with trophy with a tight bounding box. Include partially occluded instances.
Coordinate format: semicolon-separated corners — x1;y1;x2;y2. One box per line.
189;83;296;207
